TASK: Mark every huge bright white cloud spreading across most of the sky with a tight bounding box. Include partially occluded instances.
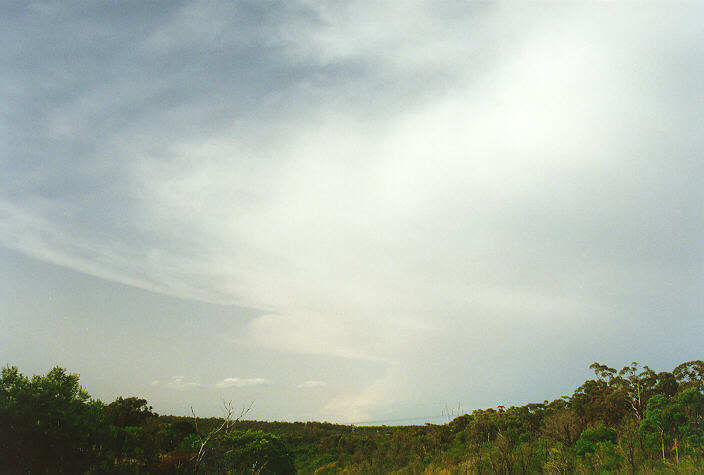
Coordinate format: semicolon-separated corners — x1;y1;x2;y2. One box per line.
0;2;704;420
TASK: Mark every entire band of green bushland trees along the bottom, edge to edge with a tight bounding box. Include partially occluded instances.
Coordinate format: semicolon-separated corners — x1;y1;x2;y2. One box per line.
0;360;704;473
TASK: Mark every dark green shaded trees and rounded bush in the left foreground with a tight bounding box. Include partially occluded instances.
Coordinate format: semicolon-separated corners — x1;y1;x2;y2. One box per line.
0;366;296;474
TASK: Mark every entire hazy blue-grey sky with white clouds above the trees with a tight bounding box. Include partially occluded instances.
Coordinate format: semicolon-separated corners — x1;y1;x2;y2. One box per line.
0;0;704;424
